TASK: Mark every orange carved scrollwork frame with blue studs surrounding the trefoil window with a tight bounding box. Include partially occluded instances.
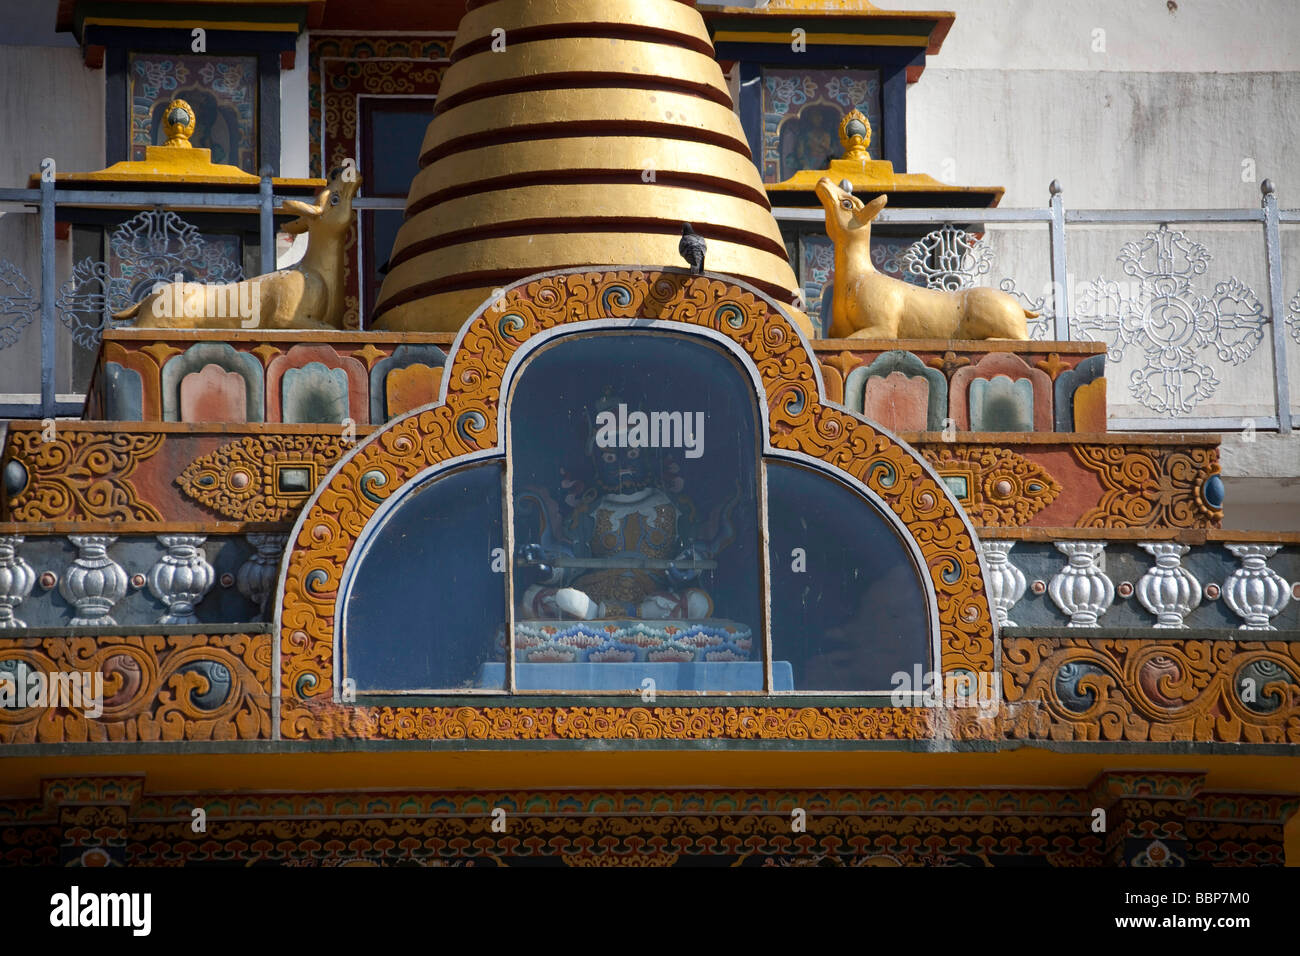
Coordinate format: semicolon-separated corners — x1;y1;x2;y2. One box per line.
277;269;996;739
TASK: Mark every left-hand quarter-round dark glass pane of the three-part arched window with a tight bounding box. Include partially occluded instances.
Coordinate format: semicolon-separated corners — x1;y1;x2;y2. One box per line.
345;462;506;692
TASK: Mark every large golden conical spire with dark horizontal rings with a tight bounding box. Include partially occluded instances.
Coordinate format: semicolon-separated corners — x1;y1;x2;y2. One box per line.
376;0;798;330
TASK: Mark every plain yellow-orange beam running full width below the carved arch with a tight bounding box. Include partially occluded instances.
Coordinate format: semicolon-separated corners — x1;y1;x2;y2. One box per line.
0;747;1300;801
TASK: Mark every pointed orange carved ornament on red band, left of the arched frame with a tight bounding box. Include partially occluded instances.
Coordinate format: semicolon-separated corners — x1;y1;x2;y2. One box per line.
176;434;345;522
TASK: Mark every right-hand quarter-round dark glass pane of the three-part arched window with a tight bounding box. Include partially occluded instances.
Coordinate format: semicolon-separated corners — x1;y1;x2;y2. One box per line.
767;462;931;691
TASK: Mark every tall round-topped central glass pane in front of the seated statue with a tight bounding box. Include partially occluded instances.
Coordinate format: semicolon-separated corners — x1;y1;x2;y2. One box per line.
510;332;763;691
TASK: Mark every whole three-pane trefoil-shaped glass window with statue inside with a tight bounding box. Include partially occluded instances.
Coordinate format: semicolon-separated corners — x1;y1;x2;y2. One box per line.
342;329;932;695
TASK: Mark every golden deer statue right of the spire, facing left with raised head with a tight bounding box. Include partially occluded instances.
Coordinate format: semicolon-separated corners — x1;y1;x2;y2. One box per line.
816;177;1039;341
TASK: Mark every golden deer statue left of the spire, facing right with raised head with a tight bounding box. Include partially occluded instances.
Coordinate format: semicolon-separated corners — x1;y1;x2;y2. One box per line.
113;164;361;329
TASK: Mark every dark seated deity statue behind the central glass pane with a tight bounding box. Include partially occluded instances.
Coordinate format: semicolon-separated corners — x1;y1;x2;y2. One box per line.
520;394;740;620
